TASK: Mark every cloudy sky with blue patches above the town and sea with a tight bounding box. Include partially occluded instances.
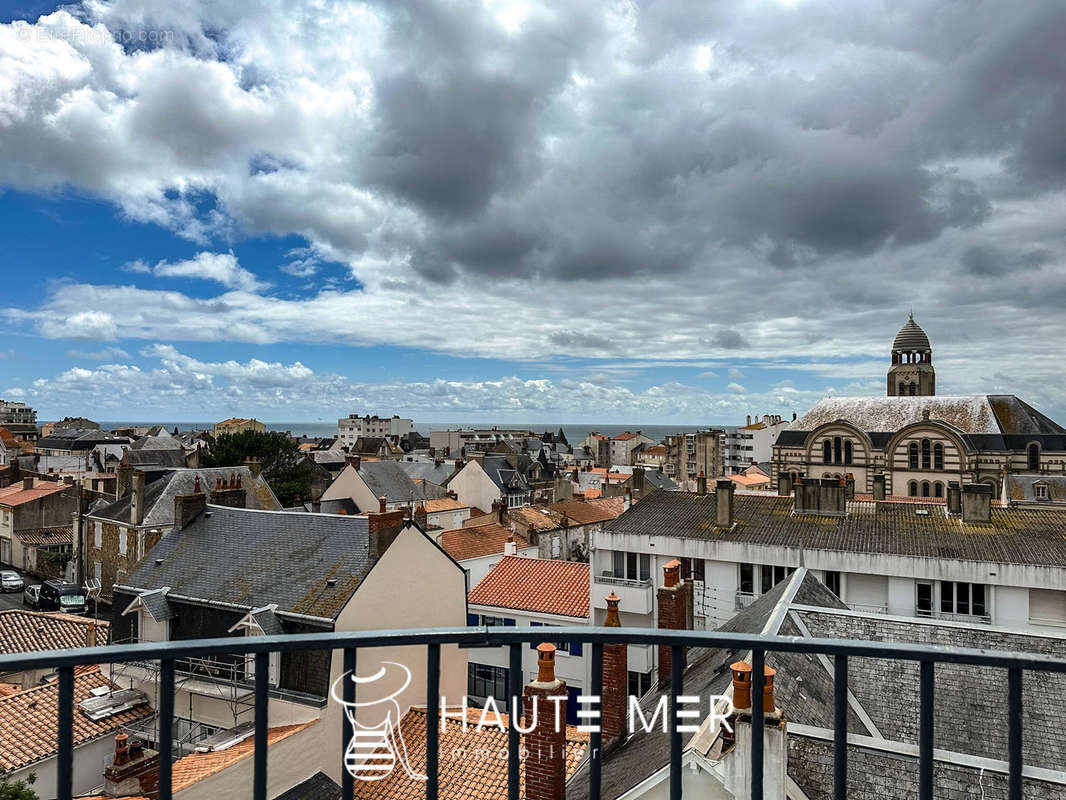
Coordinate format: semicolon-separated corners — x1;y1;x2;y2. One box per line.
0;0;1066;423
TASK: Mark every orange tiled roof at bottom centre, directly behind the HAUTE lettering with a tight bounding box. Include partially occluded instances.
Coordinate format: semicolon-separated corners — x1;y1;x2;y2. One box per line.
355;708;588;800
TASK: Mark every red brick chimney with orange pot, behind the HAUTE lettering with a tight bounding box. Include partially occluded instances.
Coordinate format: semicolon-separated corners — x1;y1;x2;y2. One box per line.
522;642;566;800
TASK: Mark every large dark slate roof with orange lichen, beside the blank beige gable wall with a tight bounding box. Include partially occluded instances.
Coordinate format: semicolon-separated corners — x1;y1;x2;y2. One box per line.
116;506;373;619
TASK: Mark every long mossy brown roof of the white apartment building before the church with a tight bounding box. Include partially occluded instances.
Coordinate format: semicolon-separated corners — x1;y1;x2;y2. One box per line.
603;492;1066;567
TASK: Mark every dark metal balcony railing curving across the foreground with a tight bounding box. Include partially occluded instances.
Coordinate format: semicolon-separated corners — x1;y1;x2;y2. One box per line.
0;626;1066;800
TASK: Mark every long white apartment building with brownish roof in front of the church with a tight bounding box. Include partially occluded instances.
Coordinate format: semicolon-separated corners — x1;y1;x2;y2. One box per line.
591;479;1066;644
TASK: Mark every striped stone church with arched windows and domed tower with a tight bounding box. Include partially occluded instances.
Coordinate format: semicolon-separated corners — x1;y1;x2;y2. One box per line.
772;316;1066;499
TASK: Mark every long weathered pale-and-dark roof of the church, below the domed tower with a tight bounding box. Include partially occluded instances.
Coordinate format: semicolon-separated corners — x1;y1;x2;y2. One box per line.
778;395;1066;435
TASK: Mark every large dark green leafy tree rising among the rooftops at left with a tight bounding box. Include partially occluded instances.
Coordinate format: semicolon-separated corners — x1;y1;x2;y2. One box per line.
203;431;313;507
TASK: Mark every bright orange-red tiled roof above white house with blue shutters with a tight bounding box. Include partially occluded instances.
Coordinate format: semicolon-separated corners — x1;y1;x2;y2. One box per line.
469;556;588;619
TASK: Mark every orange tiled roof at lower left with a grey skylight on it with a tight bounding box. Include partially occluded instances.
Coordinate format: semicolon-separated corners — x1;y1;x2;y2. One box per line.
0;667;151;772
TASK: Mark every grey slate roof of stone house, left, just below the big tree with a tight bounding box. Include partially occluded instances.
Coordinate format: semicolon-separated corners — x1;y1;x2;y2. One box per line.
90;466;281;528
